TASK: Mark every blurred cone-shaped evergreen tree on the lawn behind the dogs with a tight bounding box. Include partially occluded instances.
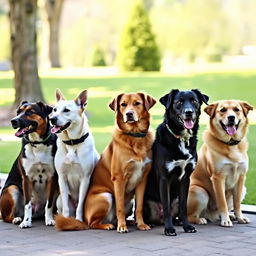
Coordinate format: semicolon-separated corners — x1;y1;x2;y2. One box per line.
118;1;160;71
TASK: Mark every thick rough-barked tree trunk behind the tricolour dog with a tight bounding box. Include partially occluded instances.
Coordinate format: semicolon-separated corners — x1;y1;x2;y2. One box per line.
9;0;43;106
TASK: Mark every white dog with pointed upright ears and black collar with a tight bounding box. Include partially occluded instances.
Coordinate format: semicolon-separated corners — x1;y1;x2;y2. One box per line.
50;89;99;225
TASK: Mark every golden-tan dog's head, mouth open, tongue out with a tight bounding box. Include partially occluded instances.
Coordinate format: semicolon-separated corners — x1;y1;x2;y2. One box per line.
204;100;253;141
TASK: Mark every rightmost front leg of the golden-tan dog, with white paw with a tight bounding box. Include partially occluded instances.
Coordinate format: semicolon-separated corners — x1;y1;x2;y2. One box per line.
233;174;250;224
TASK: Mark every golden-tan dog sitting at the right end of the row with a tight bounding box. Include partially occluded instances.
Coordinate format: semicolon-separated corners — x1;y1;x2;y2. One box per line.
188;100;253;227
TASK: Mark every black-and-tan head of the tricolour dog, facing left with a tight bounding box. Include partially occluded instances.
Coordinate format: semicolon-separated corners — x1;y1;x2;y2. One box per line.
11;101;52;137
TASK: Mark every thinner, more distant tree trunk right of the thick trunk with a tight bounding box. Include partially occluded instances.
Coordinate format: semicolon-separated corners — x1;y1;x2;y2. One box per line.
45;0;64;67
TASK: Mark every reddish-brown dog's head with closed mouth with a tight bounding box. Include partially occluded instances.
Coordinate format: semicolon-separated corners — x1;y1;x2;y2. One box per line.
109;92;156;131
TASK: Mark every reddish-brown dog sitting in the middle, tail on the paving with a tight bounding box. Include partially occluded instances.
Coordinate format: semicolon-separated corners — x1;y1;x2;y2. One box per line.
57;93;156;233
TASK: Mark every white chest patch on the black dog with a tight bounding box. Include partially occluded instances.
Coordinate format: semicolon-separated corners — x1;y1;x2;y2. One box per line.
166;141;196;180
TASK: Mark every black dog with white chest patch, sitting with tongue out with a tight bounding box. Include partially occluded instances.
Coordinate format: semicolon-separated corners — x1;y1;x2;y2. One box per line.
144;89;209;236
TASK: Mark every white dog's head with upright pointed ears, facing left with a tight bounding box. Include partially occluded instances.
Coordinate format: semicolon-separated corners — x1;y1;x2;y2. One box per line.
50;89;87;133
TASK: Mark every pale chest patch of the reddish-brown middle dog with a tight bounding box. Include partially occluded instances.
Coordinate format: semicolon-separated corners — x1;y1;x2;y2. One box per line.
126;157;151;192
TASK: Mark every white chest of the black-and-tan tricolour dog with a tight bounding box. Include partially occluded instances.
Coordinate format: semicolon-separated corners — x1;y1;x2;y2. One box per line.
22;144;54;181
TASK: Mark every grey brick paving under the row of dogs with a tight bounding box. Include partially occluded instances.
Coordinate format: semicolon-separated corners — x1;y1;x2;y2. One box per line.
0;214;256;256
